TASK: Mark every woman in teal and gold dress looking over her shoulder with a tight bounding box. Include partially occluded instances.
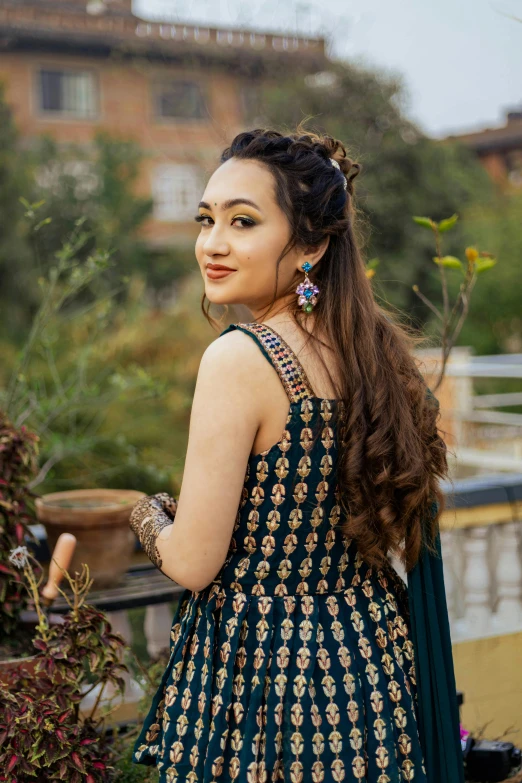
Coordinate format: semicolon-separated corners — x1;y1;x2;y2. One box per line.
131;125;463;783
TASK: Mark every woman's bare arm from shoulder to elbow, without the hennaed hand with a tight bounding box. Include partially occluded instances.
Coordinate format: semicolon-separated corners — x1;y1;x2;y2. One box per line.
134;331;266;591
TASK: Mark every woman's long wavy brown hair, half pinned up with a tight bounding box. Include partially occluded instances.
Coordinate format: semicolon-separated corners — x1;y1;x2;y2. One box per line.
201;123;448;572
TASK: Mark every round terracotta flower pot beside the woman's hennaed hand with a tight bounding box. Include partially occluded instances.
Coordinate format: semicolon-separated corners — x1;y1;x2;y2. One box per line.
36;489;144;589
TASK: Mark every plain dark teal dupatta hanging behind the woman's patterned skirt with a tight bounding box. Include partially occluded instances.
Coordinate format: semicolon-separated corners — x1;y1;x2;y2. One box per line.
408;533;464;783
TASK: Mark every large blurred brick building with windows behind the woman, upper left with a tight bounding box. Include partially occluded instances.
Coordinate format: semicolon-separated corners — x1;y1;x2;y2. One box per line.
0;0;326;246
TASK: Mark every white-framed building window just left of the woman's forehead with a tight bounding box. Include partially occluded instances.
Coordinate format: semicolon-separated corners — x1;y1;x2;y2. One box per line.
152;163;203;223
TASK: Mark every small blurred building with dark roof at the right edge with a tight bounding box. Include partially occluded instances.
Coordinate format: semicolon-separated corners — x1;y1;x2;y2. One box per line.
442;109;522;192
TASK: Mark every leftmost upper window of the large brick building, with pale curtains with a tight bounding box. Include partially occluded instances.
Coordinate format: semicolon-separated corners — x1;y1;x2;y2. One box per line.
39;68;97;117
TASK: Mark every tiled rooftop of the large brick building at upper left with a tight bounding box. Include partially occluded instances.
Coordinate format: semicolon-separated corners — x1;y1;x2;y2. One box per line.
0;0;325;72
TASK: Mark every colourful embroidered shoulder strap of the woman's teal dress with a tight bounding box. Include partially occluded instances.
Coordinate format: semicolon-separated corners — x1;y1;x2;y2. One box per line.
220;321;314;402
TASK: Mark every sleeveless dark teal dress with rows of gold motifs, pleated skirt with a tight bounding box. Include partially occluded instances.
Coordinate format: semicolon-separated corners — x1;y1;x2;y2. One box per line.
133;322;463;783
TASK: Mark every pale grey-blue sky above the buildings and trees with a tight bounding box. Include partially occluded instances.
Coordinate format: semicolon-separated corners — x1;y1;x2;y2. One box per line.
134;0;522;138
